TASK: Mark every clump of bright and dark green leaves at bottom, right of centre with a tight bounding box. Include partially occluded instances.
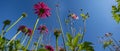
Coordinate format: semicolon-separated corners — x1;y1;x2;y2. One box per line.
66;33;94;51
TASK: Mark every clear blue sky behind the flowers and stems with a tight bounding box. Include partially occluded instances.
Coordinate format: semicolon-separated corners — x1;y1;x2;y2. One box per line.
0;0;120;51
